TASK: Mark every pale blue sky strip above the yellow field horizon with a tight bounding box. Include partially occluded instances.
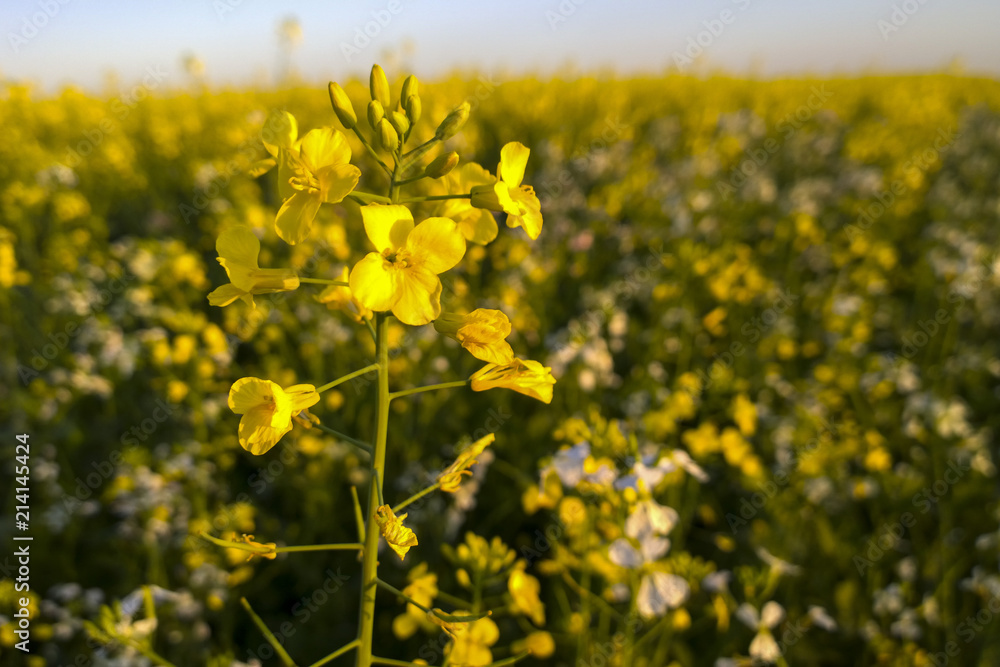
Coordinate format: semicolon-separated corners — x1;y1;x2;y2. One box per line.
0;0;1000;90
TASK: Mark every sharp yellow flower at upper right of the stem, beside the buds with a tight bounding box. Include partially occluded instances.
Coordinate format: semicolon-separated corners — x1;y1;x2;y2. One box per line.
471;141;542;240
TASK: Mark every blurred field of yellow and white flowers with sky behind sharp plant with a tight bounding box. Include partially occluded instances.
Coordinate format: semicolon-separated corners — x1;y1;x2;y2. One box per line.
0;0;1000;667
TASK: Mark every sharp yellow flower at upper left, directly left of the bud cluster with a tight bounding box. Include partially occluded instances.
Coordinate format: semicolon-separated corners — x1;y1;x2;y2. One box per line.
274;127;361;245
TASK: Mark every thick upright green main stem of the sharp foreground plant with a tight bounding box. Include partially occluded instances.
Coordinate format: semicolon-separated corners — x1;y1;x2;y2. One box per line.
355;313;389;667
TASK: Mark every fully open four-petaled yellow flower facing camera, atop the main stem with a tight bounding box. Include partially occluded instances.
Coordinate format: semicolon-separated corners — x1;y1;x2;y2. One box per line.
350;204;465;326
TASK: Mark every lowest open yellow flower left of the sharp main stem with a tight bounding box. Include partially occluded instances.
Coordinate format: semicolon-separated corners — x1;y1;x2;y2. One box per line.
229;378;319;454
